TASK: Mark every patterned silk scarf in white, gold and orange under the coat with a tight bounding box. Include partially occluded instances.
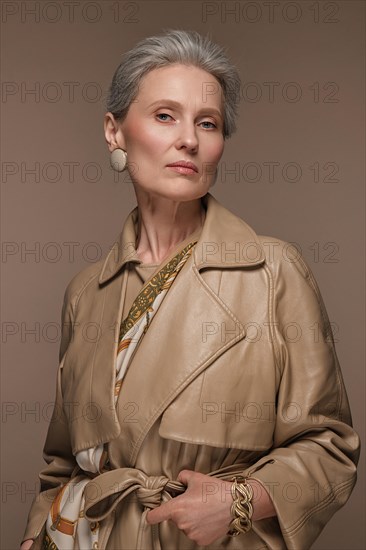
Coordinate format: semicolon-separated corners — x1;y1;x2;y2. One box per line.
42;240;197;550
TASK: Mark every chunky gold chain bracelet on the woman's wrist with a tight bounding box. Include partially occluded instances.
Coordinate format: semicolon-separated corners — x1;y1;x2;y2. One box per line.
228;476;253;537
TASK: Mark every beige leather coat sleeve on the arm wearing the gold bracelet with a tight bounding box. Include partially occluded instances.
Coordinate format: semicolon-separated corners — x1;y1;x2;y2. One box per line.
245;245;359;550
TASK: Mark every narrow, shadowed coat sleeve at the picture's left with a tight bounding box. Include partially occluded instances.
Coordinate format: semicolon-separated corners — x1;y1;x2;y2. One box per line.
22;285;77;550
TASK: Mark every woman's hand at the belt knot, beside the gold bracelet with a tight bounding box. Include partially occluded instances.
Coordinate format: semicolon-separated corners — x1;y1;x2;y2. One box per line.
146;470;233;546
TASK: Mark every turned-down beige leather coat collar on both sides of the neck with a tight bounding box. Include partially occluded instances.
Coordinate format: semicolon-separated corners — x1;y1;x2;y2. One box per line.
99;193;265;284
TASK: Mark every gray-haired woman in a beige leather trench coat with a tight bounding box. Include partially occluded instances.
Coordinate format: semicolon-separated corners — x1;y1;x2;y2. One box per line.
22;30;359;550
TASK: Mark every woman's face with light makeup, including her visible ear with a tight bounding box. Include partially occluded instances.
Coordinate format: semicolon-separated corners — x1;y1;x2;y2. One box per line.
106;64;224;201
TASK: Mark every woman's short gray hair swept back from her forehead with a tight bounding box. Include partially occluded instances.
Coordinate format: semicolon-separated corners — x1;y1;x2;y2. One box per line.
106;29;240;139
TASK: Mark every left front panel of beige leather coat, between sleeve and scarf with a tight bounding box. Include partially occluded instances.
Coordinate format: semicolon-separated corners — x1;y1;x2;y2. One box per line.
61;272;127;454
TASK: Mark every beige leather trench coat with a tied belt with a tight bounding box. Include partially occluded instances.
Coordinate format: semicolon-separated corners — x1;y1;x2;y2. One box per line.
23;193;359;550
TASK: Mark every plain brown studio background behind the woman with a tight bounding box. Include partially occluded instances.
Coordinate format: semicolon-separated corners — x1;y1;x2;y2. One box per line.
1;0;366;550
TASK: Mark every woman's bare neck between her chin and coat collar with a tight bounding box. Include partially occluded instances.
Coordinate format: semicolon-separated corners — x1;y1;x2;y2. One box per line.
136;195;205;264
